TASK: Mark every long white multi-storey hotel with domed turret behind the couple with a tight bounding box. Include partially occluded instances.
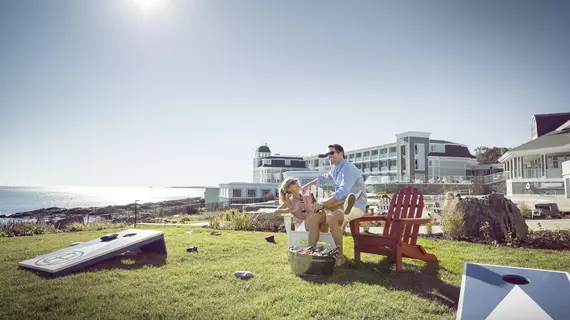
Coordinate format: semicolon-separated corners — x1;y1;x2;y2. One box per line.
253;131;478;184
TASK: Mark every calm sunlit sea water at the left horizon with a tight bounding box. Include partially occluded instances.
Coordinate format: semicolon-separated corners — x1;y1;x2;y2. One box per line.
0;186;204;215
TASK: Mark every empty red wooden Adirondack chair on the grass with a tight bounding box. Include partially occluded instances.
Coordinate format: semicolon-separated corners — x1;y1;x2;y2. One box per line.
350;186;437;272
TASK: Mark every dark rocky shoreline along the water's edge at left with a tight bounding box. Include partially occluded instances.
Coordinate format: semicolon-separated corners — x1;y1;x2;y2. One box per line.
0;197;204;219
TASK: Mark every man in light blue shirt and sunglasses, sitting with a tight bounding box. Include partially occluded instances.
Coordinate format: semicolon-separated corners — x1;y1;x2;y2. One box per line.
304;144;368;266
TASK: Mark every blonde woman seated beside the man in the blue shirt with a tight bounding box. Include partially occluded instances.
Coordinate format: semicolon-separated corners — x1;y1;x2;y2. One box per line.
274;178;329;246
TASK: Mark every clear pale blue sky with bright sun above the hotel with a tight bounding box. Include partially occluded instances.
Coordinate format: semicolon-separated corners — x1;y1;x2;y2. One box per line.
0;0;570;186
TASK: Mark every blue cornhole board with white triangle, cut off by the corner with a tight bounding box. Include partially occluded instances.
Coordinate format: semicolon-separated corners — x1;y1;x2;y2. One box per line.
456;263;570;320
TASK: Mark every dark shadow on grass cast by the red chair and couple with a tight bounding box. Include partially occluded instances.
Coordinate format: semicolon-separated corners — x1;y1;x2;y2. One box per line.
299;258;460;309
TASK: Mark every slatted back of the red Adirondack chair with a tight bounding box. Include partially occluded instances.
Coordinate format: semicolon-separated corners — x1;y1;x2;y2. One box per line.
384;186;424;245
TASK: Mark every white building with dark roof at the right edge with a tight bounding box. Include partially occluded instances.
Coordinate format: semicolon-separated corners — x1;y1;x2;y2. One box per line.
499;113;570;195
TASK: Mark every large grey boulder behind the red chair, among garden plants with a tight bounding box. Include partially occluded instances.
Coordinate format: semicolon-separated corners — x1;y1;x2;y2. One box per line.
443;193;528;243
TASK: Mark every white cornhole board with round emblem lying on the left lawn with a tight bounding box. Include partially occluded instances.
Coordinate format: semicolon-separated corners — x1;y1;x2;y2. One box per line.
19;229;166;276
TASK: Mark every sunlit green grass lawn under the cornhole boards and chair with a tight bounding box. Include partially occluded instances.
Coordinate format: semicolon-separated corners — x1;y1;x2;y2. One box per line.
0;226;570;320
